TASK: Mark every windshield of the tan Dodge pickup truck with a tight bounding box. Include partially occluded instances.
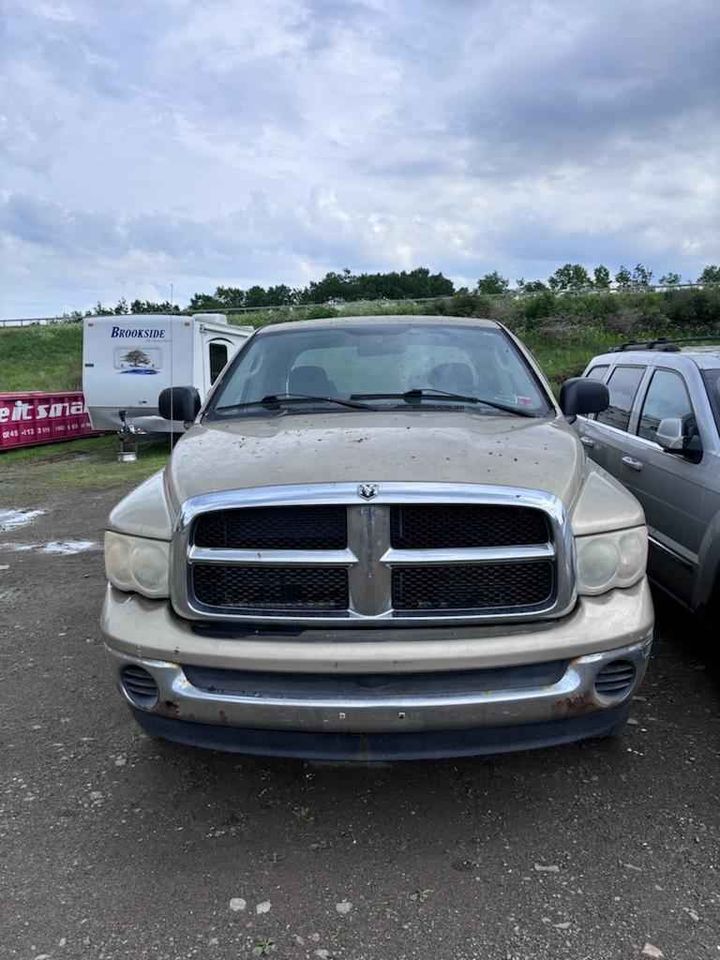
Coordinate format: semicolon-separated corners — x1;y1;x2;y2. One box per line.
207;318;554;418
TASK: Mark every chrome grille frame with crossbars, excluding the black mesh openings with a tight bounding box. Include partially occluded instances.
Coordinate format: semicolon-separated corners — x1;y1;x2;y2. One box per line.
171;482;576;628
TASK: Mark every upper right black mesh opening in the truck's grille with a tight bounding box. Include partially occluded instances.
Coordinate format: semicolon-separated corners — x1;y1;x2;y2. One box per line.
390;503;550;550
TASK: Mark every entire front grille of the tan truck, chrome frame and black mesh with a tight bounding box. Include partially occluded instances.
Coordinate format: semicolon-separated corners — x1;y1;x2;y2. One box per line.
173;483;574;626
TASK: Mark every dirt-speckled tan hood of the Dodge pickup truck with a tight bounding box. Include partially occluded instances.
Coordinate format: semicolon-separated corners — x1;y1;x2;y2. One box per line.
168;410;584;506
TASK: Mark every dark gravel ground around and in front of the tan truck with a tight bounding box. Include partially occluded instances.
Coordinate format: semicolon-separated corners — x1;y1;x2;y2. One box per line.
0;491;720;960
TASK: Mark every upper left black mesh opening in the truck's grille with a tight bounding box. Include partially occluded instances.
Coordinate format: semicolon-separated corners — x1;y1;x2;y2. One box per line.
193;504;347;550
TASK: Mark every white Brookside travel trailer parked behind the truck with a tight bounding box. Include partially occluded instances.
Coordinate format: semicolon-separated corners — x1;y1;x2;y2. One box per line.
83;313;253;433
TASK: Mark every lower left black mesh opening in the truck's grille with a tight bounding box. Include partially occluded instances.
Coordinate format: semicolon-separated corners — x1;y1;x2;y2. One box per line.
192;564;349;611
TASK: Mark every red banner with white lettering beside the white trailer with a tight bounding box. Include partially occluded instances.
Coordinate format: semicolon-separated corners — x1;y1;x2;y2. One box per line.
0;391;94;451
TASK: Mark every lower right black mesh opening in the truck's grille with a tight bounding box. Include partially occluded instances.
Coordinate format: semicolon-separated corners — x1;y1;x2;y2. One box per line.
392;560;554;611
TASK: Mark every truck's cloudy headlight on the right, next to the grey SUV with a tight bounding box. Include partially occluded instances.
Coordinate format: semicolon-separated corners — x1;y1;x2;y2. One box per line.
575;527;647;596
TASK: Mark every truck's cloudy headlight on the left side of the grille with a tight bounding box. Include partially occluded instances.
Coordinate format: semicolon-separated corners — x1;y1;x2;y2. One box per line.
105;531;170;597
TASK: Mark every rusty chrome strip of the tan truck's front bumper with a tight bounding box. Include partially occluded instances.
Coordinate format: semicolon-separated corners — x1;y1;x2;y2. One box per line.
107;632;652;734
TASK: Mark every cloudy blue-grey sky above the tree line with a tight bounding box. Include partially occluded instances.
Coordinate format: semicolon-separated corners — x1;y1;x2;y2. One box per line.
0;0;720;317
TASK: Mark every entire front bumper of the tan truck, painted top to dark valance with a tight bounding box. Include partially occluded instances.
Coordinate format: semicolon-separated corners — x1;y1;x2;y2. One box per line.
103;583;653;760
